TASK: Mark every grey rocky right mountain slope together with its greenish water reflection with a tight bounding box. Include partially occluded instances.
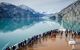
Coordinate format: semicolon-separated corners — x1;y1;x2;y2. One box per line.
58;0;80;32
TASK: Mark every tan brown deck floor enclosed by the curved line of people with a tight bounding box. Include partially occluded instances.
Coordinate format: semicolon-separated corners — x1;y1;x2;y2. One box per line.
19;32;80;50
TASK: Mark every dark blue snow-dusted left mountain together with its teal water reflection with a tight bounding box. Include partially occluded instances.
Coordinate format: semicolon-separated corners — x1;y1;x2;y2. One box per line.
0;2;44;31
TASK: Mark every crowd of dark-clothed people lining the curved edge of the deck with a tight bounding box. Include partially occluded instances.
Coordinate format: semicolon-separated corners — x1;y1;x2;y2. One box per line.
5;29;79;50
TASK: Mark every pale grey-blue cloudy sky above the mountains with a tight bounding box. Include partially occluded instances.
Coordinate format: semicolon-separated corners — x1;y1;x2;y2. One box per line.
0;0;76;13
